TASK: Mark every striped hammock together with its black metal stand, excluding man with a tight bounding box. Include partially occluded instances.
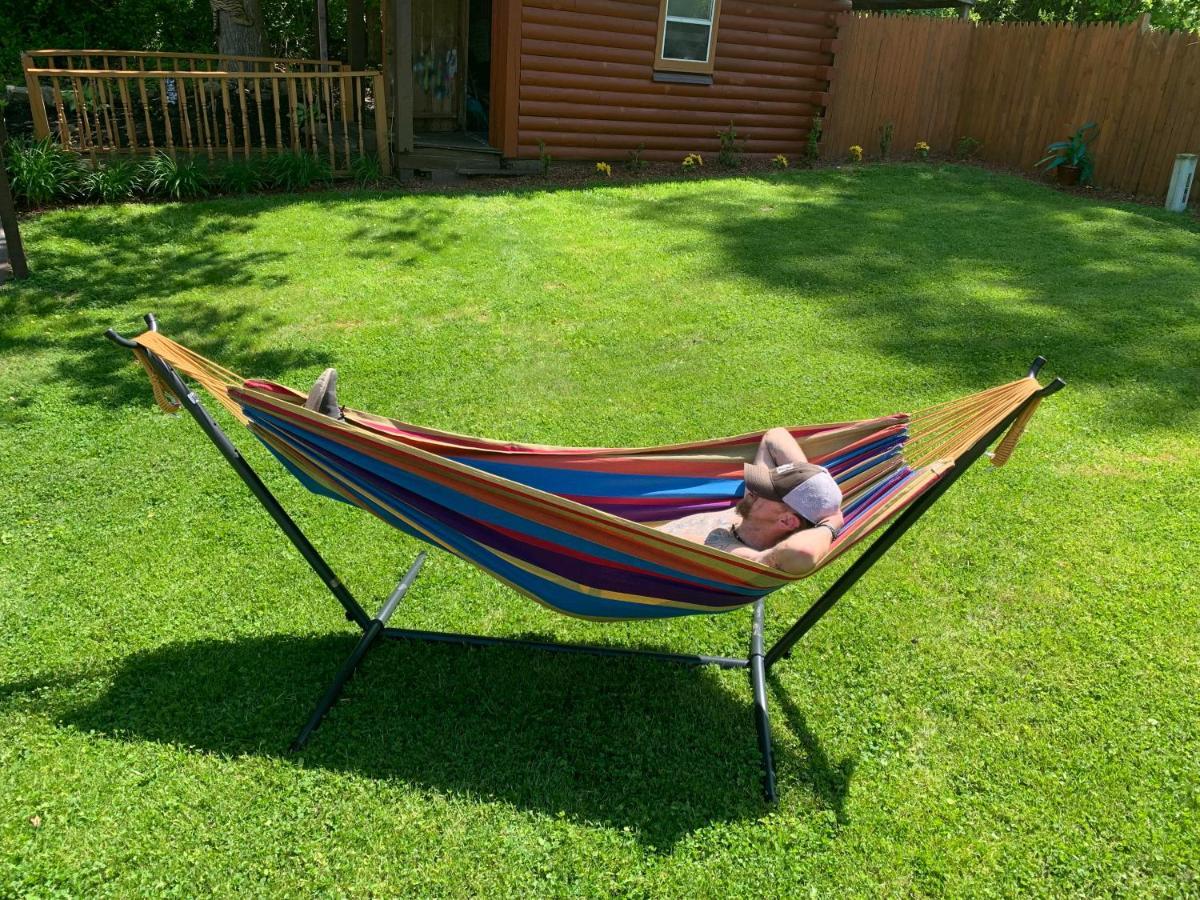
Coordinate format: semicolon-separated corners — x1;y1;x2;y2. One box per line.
107;316;1064;802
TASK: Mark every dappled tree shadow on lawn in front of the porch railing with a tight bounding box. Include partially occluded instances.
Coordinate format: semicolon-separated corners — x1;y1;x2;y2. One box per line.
0;194;458;407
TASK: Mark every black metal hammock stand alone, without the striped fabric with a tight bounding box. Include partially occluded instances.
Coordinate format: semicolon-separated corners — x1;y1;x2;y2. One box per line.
104;314;1066;803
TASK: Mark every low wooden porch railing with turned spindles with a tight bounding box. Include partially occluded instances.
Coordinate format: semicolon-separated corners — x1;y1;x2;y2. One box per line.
24;50;391;174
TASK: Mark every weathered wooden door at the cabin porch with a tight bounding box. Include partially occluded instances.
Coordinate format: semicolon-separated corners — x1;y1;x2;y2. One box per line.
413;0;469;133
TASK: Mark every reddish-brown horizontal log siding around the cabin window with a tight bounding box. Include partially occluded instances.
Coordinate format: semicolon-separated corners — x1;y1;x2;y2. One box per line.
517;0;850;161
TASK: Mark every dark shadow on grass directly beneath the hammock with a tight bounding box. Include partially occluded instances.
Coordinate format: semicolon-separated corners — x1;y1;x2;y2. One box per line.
60;636;844;848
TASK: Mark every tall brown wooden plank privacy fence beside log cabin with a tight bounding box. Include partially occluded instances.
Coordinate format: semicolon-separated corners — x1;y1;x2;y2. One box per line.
822;14;1200;196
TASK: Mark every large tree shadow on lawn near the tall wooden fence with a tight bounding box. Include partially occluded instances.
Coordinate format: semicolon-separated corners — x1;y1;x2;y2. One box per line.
635;166;1200;425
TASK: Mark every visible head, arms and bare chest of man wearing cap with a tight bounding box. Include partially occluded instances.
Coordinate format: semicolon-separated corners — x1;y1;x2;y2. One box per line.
659;428;842;575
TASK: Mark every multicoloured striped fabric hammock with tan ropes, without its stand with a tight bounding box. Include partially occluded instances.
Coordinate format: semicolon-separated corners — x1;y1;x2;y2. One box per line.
134;331;1038;620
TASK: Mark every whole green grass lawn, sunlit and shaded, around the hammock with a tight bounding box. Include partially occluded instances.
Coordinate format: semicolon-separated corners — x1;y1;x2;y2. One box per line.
0;166;1200;898
